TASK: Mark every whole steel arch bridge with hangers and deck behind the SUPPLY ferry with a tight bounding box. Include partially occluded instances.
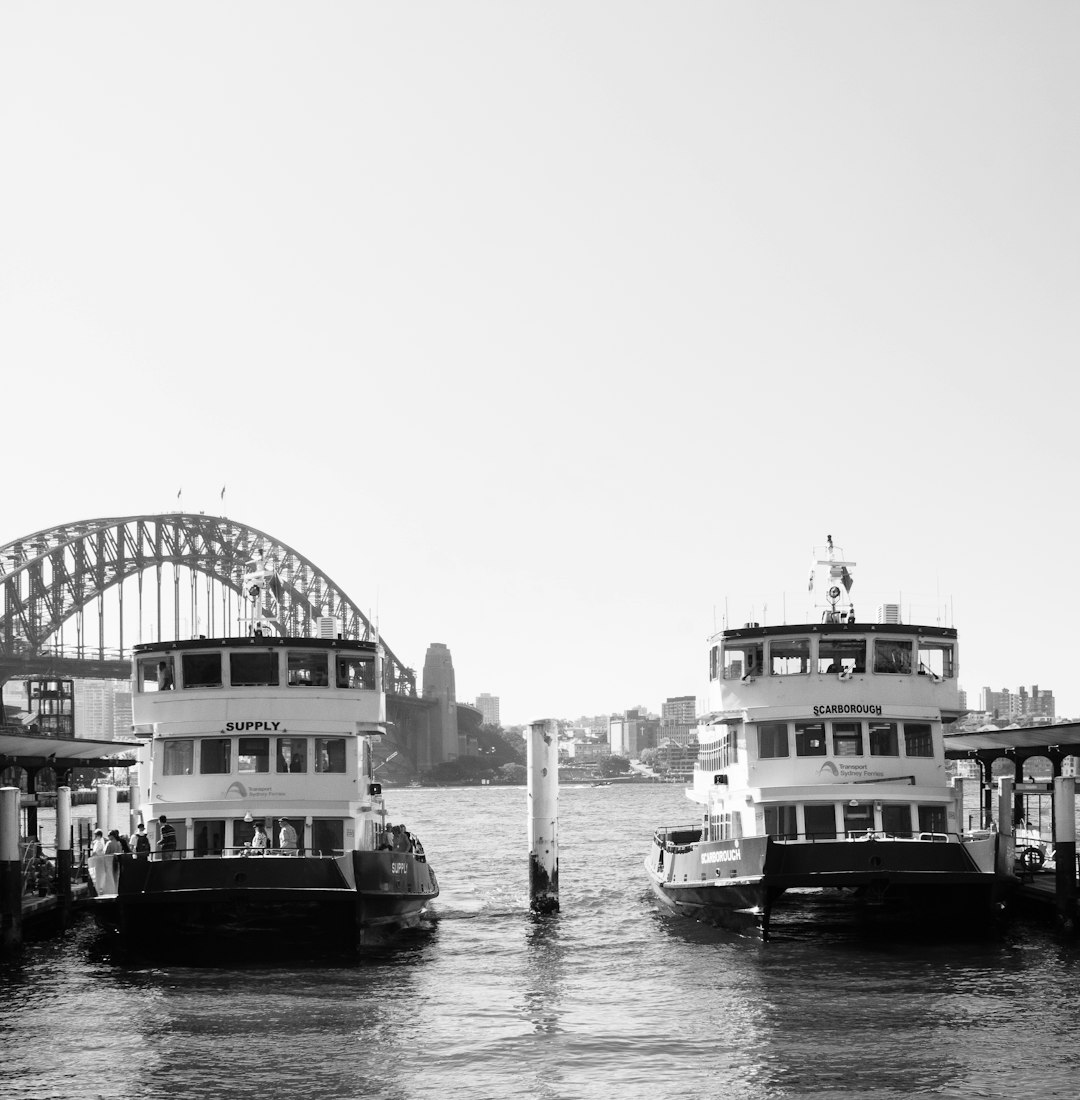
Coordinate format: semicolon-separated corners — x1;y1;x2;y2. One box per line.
0;513;473;772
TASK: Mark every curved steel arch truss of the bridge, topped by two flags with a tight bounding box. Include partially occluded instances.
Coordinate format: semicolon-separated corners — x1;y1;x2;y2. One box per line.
0;513;416;697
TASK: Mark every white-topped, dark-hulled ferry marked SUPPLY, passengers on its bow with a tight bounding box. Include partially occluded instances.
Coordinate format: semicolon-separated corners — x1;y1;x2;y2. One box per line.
88;558;439;948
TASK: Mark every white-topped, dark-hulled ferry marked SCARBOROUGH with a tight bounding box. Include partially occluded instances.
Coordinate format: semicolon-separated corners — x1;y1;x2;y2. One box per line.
646;538;1004;936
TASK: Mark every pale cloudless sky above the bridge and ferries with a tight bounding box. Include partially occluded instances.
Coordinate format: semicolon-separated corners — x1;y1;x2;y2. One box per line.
0;8;1080;723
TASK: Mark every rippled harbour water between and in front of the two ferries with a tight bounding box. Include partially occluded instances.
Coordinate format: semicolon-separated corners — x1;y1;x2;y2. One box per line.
0;785;1080;1100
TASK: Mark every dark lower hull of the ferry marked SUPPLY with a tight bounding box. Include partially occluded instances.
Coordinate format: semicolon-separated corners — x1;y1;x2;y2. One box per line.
95;851;439;948
